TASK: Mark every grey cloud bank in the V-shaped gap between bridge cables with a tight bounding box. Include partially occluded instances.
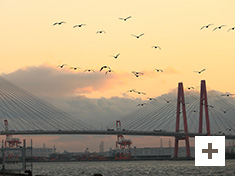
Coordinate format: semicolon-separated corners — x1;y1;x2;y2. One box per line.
49;96;142;126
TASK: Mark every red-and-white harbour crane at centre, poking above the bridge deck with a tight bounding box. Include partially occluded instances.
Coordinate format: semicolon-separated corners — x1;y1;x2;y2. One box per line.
115;120;132;160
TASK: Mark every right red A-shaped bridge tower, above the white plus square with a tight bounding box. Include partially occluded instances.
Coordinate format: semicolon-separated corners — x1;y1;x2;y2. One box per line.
199;80;211;136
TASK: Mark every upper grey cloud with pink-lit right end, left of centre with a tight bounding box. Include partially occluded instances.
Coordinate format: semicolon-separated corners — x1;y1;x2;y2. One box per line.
4;64;128;97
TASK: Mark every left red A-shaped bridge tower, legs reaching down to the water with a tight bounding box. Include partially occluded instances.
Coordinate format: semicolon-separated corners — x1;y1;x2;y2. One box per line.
174;82;190;158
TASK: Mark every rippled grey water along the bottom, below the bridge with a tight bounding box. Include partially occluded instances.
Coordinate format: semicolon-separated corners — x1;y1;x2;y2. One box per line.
34;160;235;176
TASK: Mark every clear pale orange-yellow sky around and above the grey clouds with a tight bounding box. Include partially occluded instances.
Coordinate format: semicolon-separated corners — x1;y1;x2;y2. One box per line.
0;0;235;97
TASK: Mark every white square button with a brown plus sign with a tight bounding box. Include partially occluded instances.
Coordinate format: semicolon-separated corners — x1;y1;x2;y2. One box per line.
195;136;225;166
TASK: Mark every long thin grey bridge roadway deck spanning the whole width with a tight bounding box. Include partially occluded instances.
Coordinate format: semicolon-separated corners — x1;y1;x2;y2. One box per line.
0;130;235;139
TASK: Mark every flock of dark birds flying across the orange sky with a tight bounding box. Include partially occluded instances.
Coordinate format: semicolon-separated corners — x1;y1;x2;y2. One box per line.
53;16;235;106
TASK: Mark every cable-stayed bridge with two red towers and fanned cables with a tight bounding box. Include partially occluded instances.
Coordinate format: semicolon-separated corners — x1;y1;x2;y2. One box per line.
0;77;235;156
